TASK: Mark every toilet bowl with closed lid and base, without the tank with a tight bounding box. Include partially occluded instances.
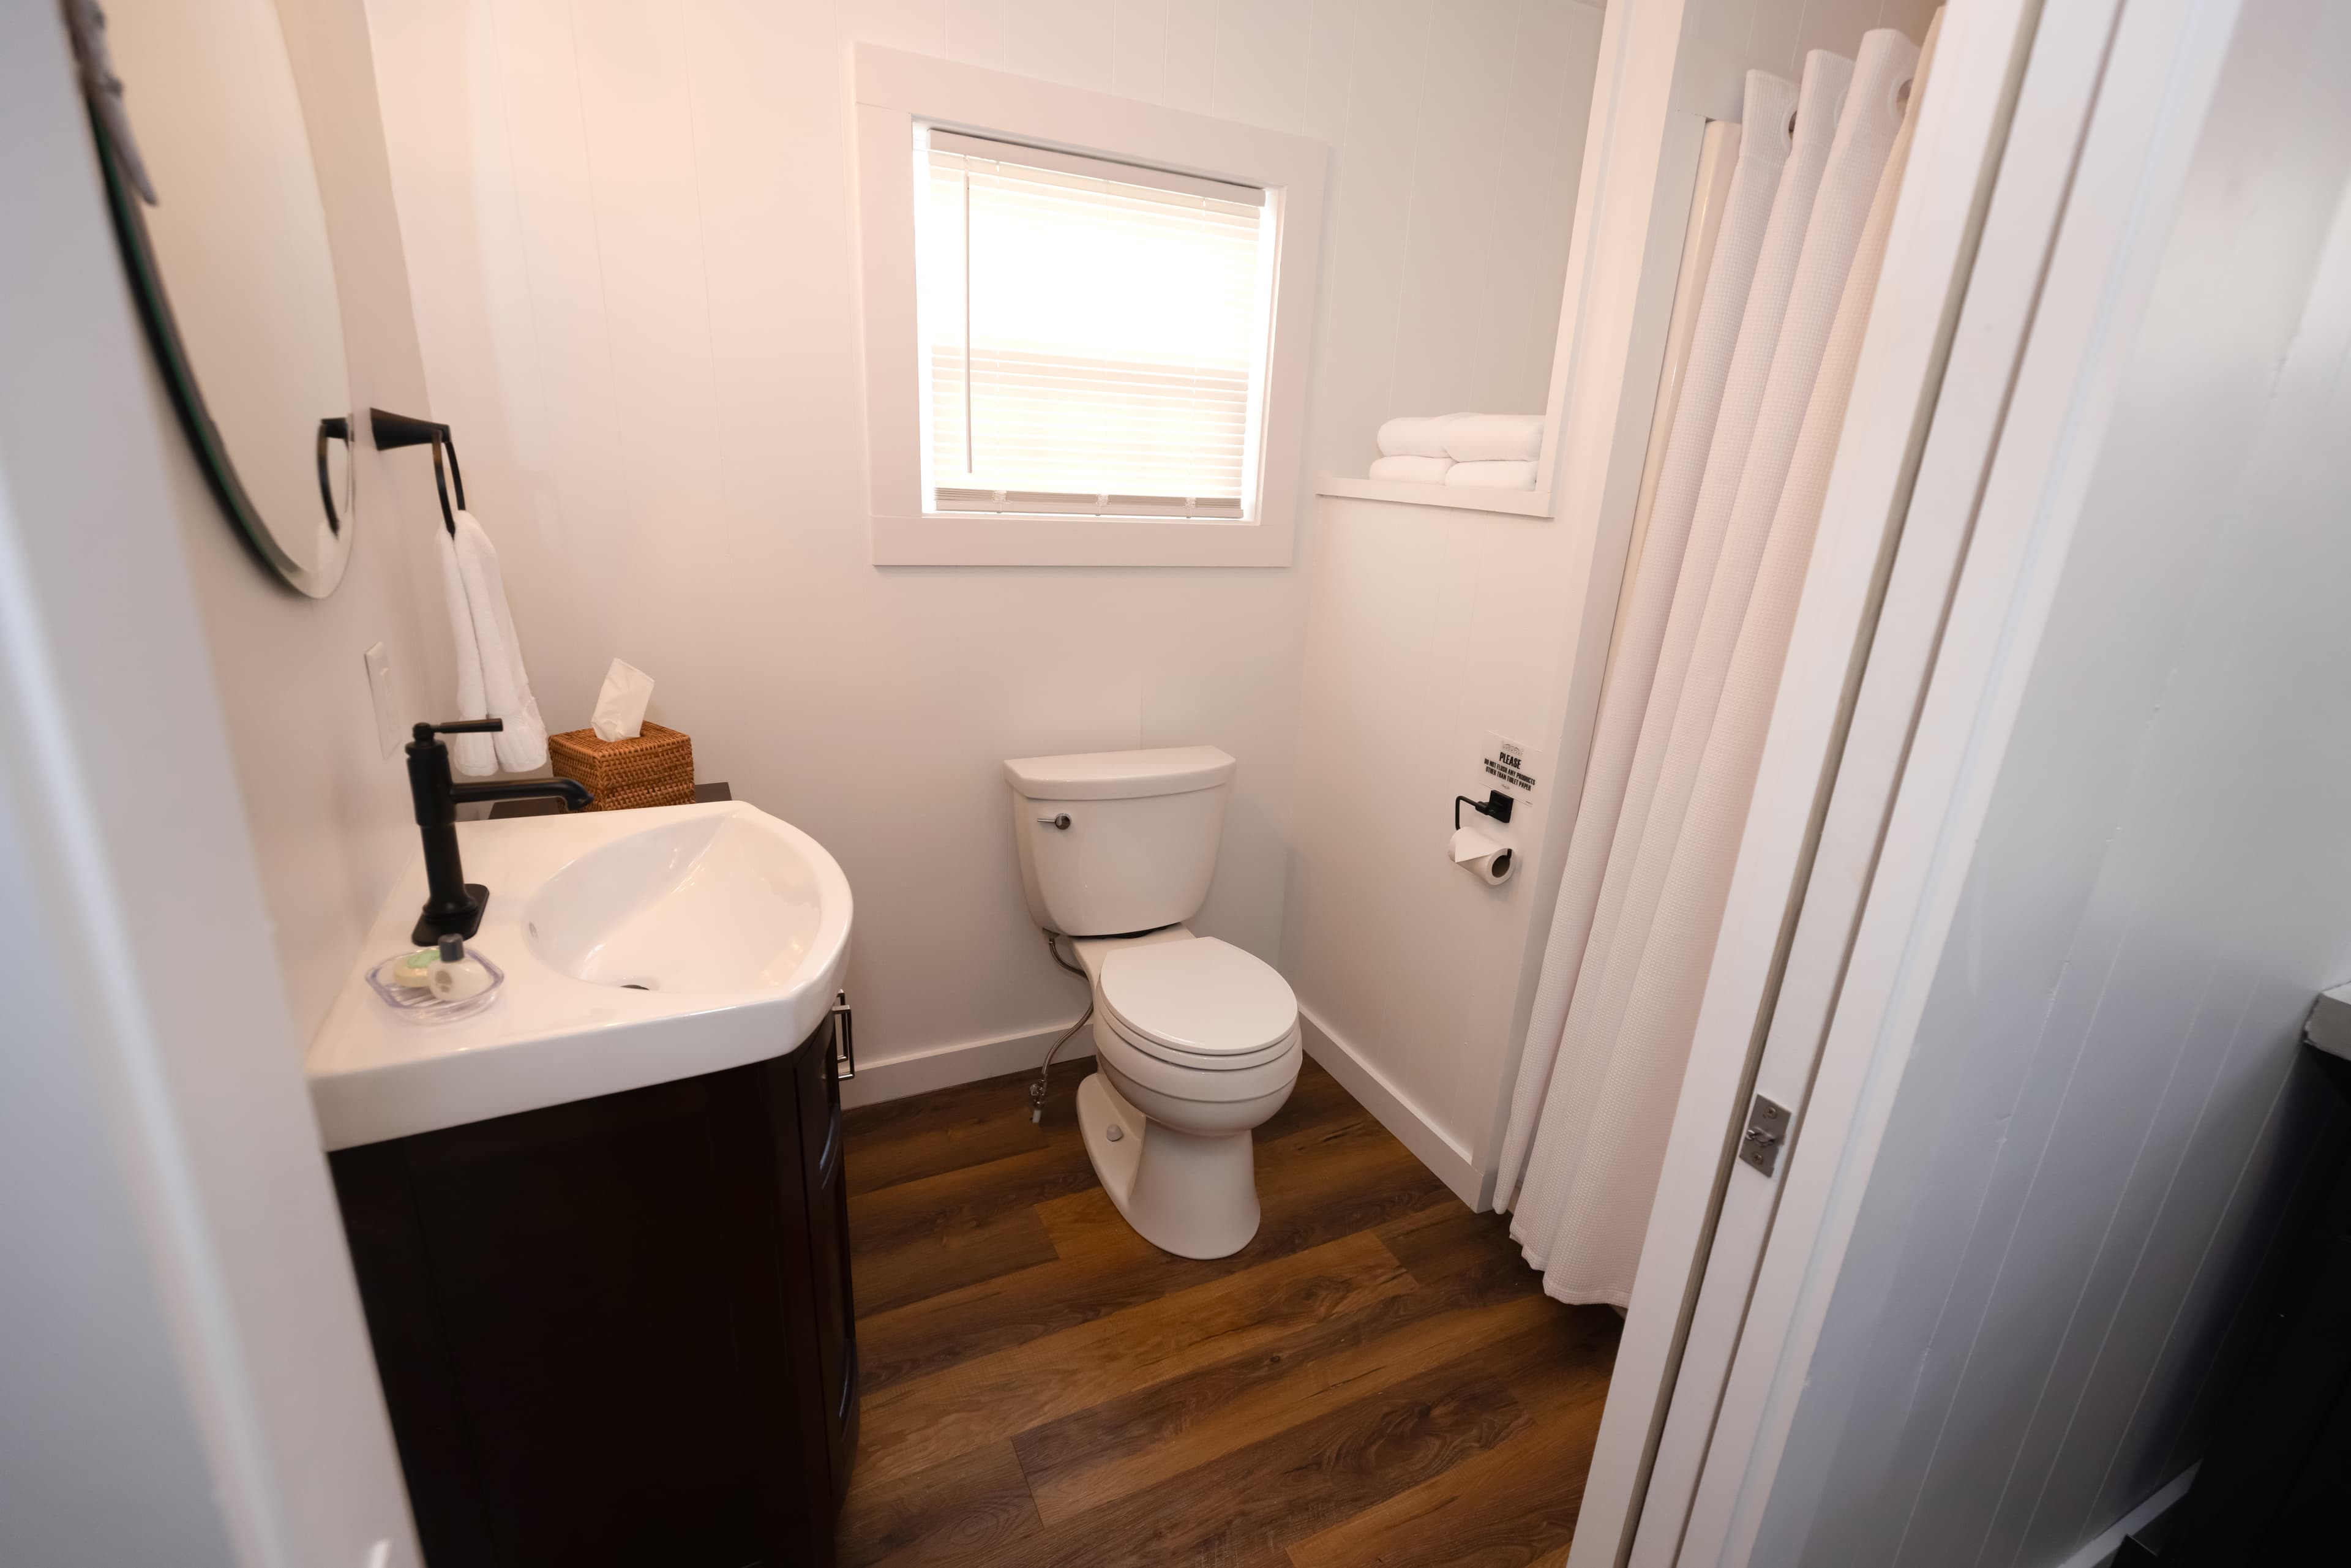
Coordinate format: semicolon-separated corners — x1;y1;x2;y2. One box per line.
1074;926;1305;1258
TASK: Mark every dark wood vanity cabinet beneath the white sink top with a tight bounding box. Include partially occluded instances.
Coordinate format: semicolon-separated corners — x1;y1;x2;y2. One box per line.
329;1020;858;1568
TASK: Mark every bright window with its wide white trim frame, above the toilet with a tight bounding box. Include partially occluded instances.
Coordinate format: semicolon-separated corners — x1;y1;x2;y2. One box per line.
856;45;1326;566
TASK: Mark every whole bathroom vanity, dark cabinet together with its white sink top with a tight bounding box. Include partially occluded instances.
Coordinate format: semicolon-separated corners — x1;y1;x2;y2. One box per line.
303;801;858;1568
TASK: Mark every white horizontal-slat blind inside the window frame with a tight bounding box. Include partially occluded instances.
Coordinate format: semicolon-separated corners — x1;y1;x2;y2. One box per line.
917;129;1272;522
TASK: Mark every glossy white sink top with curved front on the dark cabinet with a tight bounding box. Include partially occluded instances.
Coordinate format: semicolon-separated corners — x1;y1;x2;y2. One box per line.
303;801;851;1150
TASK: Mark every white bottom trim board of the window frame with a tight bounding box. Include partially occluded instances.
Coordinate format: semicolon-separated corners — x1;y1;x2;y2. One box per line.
872;512;1291;566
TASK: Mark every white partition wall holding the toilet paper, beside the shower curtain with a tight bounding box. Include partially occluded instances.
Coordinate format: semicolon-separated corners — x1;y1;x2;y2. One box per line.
1284;0;1932;1185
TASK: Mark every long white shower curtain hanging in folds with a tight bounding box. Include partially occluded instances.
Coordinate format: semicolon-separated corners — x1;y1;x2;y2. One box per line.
1495;31;1921;1307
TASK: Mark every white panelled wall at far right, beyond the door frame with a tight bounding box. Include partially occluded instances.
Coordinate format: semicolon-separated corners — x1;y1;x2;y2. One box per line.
1754;0;2351;1566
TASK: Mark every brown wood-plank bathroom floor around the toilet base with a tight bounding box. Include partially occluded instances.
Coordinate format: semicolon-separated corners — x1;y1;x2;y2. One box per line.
839;1060;1618;1568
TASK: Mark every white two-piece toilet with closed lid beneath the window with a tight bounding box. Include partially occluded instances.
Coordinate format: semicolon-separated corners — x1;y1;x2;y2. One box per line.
1004;745;1302;1258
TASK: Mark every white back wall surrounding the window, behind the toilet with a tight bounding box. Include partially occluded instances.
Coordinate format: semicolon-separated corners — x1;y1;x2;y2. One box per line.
353;0;1584;1070
